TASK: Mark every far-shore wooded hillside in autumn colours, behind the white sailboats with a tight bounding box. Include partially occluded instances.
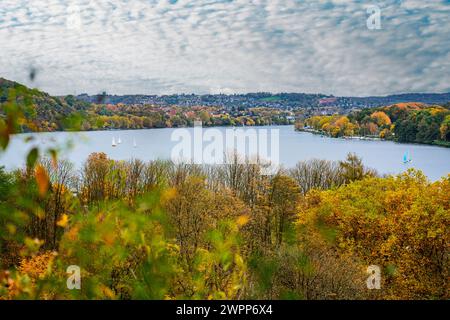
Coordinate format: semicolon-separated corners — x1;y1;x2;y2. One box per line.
0;78;293;132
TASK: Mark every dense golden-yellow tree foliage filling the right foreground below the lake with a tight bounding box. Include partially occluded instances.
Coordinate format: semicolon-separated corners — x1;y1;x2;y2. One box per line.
298;170;450;299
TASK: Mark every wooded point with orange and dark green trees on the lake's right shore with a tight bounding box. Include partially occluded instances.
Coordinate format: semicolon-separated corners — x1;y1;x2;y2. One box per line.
296;103;450;147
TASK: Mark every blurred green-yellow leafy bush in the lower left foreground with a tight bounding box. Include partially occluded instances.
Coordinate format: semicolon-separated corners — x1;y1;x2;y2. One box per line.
55;192;180;299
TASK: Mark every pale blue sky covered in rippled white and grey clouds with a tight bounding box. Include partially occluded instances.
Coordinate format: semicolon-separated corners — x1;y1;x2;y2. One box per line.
0;0;450;96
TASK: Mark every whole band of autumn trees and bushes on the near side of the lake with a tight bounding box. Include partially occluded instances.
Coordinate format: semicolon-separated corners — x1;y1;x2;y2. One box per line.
0;82;450;300
